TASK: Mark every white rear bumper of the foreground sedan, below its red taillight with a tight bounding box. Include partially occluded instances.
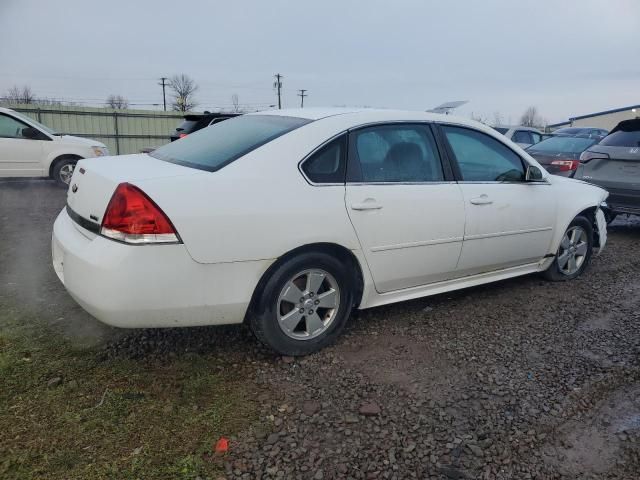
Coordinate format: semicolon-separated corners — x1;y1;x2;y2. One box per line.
52;210;271;328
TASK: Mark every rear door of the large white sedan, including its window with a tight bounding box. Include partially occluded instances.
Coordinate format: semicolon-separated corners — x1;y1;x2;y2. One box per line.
345;123;464;293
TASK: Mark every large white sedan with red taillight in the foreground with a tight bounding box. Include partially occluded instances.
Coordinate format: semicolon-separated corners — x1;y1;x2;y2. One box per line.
52;109;607;355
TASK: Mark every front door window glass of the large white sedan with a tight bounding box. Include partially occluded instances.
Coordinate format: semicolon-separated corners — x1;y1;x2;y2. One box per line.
442;125;524;182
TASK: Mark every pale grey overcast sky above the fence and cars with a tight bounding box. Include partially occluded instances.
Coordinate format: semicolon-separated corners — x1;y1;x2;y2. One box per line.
0;0;640;122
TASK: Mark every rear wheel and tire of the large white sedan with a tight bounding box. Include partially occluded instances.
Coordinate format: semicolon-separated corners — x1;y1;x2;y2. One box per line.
249;252;354;356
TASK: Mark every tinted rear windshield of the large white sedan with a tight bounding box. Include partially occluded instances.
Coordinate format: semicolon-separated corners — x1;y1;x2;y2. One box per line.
150;115;310;172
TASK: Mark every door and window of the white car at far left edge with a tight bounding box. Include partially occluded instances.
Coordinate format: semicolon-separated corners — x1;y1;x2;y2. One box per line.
0;113;43;177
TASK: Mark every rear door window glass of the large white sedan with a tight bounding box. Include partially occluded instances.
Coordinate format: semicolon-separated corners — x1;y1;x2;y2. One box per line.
348;124;444;183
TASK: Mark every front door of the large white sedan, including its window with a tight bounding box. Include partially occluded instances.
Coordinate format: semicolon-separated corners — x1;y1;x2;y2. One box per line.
441;125;556;275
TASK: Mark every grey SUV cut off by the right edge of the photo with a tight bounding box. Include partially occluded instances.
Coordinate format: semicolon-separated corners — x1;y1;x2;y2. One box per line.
575;119;640;220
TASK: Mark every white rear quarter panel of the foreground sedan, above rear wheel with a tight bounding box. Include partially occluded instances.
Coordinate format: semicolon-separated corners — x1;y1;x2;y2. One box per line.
135;122;359;263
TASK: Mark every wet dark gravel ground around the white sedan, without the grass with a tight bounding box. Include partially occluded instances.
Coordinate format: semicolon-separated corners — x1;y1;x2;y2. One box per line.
0;181;640;479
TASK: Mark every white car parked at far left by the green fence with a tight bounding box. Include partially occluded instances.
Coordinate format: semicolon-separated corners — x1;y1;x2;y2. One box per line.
0;107;109;186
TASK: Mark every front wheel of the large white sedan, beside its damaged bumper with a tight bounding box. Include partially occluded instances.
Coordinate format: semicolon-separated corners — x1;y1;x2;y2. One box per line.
544;216;593;282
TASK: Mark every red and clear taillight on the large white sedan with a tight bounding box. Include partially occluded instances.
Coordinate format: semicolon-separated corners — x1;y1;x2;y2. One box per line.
100;183;180;244
